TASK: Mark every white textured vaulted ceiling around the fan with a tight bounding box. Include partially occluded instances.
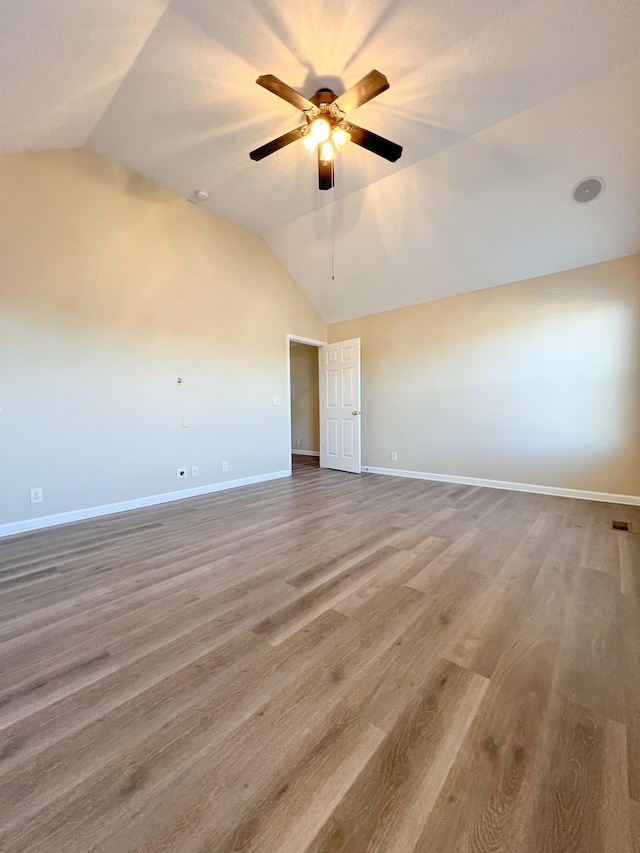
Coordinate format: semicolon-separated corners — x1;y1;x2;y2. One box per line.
0;0;640;321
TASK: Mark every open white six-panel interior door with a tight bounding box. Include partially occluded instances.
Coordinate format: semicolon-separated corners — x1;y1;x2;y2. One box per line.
320;338;360;474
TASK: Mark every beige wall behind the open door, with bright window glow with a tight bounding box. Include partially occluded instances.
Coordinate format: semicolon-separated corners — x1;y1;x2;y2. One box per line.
328;255;640;496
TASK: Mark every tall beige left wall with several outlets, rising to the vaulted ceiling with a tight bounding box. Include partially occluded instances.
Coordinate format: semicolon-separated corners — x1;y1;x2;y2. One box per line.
0;151;326;523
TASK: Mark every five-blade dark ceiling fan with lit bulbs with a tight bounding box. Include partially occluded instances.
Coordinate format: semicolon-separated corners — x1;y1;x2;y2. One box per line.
249;71;402;190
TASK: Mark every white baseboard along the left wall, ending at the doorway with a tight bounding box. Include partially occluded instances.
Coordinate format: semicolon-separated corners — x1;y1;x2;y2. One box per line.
0;471;291;538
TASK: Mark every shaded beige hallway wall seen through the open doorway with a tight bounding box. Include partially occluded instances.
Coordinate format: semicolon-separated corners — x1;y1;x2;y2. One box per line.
291;343;320;452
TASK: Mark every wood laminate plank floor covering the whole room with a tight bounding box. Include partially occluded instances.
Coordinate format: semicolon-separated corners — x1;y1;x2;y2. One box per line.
0;466;640;853
